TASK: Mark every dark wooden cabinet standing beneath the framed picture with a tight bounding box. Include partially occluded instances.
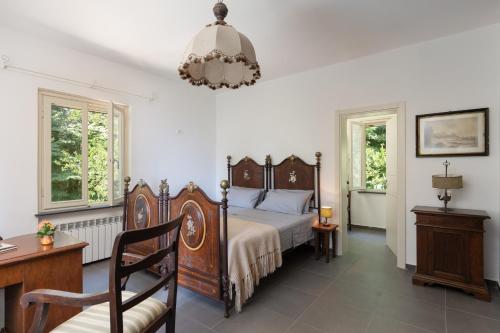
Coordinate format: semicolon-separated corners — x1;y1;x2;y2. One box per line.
412;206;490;301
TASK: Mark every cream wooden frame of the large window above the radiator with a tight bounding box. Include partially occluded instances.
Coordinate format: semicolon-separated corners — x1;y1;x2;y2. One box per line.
38;89;129;213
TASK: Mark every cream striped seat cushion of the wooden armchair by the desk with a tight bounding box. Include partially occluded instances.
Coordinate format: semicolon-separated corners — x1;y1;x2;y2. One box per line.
52;291;167;333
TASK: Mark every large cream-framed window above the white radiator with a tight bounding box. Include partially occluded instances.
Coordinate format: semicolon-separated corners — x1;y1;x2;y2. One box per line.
39;90;128;212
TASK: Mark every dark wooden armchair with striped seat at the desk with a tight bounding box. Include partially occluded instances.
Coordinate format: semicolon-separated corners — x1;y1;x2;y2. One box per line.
21;215;184;333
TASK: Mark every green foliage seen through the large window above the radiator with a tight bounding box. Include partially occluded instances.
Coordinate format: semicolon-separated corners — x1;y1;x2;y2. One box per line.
51;105;108;202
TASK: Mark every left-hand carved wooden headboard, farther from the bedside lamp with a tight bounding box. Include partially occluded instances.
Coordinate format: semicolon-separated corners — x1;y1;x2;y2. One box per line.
227;156;268;189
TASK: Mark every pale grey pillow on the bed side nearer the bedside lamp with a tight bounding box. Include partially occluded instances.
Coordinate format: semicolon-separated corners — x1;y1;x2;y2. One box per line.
257;190;311;215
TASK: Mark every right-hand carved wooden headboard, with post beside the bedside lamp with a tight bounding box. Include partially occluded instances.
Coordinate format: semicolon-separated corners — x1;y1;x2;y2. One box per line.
268;152;321;208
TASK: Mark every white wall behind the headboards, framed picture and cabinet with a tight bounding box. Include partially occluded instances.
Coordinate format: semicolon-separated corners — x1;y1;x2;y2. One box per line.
216;25;500;281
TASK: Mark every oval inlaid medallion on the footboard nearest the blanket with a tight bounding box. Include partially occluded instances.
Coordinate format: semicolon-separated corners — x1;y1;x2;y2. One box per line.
181;200;206;251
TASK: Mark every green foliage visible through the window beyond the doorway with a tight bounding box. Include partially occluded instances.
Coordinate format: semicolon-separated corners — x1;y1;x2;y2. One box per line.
366;125;387;190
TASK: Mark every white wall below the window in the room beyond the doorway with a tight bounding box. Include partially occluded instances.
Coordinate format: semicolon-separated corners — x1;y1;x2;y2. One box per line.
351;191;387;229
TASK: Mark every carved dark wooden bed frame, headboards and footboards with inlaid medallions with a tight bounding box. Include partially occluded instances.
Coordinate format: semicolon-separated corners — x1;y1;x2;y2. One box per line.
124;153;321;318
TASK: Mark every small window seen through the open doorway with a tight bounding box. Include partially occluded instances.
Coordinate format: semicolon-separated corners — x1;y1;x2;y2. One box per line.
350;121;387;191
